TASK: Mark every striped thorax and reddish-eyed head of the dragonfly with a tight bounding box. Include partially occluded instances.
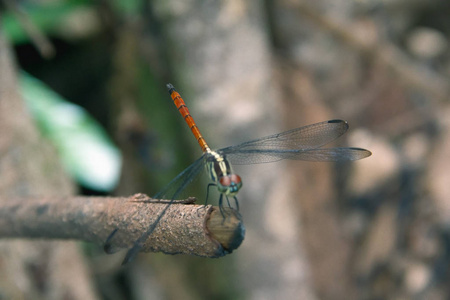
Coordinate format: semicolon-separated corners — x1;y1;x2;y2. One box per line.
205;151;242;196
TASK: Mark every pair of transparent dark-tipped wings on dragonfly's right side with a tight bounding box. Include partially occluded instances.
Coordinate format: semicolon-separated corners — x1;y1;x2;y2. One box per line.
218;120;371;165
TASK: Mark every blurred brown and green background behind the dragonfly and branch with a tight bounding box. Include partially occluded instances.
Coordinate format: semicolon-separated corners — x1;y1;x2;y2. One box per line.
0;0;450;300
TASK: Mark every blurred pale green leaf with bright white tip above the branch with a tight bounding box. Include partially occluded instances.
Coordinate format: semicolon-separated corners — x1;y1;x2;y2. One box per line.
20;73;122;191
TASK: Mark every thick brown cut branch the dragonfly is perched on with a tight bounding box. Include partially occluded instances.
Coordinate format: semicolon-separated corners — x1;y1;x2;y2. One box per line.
0;194;245;257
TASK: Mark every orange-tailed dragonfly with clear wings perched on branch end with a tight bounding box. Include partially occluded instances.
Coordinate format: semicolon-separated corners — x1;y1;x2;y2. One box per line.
114;83;372;264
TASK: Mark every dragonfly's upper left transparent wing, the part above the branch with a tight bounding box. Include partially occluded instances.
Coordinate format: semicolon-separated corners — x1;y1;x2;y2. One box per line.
153;156;203;200
